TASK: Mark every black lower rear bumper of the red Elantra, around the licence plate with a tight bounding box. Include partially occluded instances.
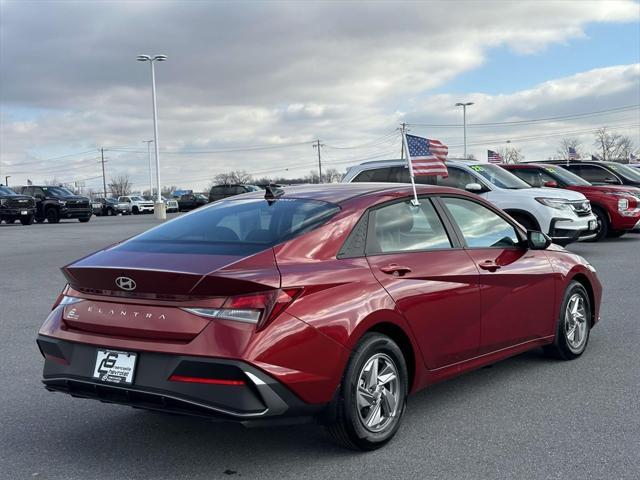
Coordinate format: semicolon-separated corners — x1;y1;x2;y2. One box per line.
37;335;324;424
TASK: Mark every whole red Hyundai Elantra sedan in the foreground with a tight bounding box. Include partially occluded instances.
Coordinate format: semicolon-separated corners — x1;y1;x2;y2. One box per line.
37;183;602;450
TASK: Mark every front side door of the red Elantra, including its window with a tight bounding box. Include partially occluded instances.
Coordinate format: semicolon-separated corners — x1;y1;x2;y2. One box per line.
439;196;557;353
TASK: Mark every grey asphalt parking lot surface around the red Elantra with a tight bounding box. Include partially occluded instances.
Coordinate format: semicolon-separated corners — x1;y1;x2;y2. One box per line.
0;216;640;480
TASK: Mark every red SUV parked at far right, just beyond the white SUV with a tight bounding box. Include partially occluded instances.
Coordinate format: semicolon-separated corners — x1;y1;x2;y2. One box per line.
500;163;640;242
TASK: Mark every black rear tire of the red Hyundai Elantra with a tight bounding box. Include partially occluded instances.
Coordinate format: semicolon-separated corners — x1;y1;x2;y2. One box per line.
326;333;409;451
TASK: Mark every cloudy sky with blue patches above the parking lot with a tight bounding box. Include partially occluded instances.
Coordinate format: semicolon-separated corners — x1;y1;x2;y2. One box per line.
0;0;640;189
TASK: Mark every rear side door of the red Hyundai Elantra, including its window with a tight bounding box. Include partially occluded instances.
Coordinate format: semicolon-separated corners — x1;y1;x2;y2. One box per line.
366;198;481;369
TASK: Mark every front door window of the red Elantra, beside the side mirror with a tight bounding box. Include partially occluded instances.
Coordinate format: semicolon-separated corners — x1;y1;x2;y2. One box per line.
442;197;520;248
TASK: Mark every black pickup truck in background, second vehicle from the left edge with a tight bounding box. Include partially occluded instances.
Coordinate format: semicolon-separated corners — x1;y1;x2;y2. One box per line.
20;185;93;223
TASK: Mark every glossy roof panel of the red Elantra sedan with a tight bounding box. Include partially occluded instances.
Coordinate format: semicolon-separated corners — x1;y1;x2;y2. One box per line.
233;182;462;204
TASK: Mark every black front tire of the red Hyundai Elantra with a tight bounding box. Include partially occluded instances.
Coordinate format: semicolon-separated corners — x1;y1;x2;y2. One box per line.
544;281;592;360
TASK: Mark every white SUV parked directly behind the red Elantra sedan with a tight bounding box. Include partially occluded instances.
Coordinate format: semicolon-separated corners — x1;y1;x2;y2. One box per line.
342;160;598;245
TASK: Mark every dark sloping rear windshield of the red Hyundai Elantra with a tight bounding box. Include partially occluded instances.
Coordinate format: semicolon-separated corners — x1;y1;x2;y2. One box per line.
116;198;340;255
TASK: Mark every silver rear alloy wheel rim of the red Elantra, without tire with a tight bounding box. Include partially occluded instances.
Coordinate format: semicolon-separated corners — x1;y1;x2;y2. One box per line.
357;353;401;432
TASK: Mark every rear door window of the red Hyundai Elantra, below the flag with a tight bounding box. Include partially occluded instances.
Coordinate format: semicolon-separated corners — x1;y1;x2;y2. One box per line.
367;199;451;254
